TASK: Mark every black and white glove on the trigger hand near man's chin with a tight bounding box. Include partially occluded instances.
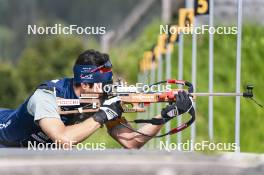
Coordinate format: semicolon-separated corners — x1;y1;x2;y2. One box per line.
93;97;123;125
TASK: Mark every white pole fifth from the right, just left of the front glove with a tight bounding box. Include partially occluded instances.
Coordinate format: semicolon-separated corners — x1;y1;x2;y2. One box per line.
165;44;171;144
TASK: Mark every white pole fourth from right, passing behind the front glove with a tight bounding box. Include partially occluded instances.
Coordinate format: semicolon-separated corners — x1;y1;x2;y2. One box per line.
177;33;184;144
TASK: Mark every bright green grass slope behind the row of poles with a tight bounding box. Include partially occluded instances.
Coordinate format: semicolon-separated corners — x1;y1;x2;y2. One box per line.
84;21;264;152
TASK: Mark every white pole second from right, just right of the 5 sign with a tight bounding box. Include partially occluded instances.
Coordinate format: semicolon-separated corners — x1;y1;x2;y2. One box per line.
208;0;214;141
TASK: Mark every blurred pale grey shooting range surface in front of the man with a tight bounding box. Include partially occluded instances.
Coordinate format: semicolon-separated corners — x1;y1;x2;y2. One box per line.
0;149;264;175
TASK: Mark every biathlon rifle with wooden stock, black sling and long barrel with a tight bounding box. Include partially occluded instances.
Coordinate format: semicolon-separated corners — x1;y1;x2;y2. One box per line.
57;79;263;137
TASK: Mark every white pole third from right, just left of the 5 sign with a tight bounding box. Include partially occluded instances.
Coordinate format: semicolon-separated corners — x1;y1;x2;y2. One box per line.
191;18;197;150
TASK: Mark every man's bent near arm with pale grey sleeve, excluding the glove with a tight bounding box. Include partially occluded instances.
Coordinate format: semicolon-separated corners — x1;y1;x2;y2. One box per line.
27;89;101;145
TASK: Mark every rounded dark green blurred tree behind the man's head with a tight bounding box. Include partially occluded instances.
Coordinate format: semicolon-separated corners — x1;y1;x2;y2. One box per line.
18;36;83;94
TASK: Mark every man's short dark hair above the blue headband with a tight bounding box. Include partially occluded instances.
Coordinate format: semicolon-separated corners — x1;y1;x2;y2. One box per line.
75;49;109;87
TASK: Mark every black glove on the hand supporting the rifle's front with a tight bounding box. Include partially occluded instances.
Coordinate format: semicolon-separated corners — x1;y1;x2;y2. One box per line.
161;91;192;121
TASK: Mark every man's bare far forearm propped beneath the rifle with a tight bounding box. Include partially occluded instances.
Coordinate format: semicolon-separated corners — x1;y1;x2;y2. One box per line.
108;115;162;149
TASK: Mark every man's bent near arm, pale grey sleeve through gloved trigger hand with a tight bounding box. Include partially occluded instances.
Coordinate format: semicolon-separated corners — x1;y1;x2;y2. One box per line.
27;89;122;145
